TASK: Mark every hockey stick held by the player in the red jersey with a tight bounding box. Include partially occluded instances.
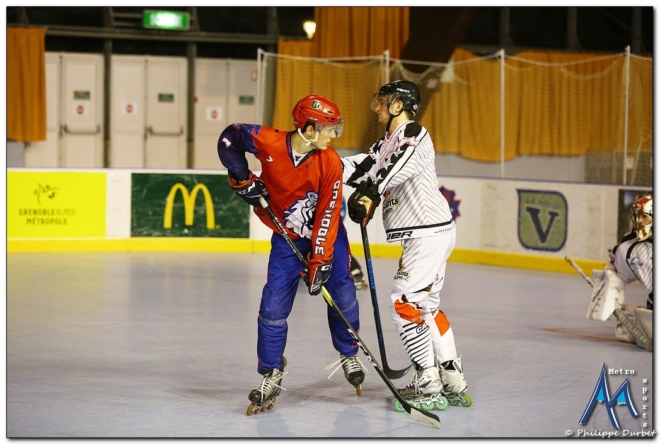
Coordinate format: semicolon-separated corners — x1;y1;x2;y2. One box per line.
259;196;442;428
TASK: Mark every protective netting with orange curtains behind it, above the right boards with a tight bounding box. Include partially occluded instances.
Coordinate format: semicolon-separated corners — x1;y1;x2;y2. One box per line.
261;49;653;185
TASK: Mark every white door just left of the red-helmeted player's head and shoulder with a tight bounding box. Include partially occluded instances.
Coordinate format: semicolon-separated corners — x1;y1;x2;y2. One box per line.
193;59;231;169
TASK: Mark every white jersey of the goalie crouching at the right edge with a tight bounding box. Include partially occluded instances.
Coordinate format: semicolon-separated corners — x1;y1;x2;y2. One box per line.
610;232;653;293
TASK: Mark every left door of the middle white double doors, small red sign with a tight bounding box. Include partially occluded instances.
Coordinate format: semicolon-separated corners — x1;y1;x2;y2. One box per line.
109;56;146;168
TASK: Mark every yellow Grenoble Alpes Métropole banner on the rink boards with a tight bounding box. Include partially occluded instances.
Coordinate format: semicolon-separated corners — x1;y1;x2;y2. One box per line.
7;171;106;238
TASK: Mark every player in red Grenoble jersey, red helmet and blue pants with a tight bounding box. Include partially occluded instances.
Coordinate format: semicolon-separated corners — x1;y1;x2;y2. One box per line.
218;95;366;415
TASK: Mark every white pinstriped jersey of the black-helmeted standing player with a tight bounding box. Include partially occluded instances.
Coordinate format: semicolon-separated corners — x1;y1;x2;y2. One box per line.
341;120;455;242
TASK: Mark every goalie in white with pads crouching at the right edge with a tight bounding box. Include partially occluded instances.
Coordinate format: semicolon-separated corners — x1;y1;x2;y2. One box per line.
587;195;653;347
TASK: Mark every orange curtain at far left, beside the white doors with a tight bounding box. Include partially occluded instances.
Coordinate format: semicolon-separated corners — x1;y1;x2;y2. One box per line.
7;27;46;142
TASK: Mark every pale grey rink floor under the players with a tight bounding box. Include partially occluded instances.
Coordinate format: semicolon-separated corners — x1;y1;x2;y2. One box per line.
6;253;653;438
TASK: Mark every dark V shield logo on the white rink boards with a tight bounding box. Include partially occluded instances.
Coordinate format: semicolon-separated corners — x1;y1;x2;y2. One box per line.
518;190;568;252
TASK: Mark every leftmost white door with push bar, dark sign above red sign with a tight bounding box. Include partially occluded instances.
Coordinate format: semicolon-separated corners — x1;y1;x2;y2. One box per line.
60;54;103;167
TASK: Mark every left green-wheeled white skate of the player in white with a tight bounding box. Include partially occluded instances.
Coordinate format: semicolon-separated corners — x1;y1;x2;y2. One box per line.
394;364;448;412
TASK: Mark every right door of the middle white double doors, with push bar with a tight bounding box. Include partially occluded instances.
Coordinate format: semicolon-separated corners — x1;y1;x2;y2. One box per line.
145;57;187;168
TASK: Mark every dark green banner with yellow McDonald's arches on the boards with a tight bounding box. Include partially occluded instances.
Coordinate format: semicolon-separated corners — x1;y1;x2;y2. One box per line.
131;173;250;238
